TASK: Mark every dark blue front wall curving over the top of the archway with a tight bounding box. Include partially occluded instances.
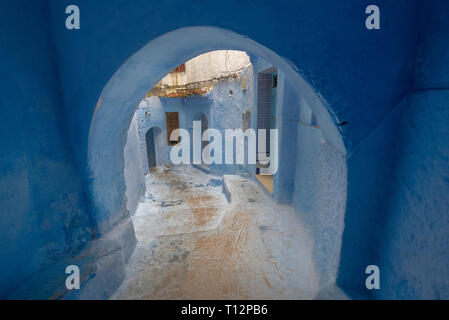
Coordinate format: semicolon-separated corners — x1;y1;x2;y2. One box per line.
45;0;419;248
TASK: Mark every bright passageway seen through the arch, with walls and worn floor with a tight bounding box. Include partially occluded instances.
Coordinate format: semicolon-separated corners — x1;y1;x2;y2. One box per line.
112;50;343;299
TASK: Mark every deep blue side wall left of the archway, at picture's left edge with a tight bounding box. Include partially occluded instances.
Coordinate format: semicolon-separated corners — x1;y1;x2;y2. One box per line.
0;1;95;297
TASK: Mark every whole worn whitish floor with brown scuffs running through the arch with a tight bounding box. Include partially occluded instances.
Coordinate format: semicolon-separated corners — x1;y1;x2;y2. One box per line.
112;166;318;299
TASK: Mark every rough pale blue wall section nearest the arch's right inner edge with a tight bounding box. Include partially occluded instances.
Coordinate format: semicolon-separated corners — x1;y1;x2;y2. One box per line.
292;123;347;286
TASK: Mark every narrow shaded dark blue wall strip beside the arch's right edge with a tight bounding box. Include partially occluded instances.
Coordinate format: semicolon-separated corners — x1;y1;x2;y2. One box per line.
338;98;408;298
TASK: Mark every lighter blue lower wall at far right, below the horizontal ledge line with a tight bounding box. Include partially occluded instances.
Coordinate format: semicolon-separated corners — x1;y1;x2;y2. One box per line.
377;89;449;299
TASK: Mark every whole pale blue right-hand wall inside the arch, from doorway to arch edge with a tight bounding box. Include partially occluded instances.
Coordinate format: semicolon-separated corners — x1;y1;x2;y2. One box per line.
252;57;347;287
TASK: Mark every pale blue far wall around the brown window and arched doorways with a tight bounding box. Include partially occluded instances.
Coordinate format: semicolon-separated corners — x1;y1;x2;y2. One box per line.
136;65;254;174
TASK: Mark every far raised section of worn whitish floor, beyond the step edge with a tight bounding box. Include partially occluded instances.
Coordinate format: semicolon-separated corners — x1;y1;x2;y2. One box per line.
133;166;227;240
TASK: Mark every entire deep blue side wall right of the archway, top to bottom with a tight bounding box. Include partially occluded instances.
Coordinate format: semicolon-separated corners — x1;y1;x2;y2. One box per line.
338;1;449;299
